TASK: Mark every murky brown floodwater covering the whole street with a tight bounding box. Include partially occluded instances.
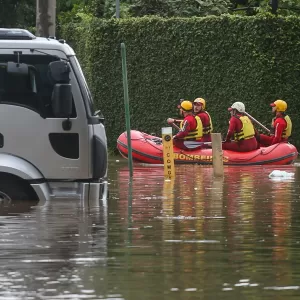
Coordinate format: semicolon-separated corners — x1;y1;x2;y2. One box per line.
0;158;300;300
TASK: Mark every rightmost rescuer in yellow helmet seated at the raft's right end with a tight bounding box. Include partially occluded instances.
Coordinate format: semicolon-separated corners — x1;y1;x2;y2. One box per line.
258;100;292;147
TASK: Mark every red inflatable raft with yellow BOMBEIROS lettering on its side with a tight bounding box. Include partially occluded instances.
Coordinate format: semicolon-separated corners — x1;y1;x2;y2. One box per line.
117;130;298;165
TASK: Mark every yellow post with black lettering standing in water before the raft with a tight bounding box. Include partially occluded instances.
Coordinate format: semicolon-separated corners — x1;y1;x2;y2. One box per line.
161;127;175;178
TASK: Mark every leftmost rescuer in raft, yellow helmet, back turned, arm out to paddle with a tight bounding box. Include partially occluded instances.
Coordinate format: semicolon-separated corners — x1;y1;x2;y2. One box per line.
167;100;202;150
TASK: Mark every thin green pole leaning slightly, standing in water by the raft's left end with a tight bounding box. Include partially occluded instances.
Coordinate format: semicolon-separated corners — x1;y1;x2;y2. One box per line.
121;43;133;177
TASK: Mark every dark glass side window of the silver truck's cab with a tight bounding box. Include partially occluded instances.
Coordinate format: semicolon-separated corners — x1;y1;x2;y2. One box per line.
0;55;76;118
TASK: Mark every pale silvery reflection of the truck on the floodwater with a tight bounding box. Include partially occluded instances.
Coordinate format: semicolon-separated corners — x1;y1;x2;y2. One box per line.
0;201;108;299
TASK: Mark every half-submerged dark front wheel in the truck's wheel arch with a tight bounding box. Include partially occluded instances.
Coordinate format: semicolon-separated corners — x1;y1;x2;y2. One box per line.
0;178;38;205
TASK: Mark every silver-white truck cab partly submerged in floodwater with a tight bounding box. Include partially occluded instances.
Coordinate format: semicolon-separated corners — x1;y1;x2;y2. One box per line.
0;28;108;205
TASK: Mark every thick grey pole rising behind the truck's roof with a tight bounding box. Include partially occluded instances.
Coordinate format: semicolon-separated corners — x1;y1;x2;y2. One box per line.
36;0;56;37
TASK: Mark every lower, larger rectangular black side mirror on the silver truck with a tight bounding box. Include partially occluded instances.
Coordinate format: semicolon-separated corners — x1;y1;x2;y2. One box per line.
51;83;73;118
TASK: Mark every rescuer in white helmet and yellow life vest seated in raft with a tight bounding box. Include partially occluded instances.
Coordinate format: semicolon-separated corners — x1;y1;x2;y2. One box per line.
222;102;257;152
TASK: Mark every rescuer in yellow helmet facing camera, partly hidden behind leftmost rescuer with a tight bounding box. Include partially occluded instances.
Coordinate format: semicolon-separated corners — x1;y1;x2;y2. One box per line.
194;98;213;142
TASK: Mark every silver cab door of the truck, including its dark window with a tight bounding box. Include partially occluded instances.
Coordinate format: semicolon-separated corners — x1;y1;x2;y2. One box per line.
0;49;91;180
